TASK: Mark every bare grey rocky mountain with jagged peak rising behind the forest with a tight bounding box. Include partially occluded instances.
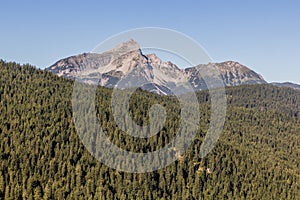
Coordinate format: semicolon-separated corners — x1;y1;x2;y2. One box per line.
46;40;266;95
